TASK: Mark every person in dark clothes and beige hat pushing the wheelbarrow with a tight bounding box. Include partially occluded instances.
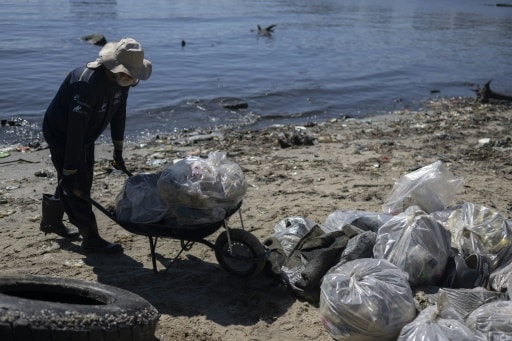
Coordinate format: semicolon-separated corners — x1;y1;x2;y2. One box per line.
40;38;152;253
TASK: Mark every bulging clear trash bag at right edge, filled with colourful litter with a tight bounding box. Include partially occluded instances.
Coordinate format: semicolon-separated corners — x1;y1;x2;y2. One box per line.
445;202;512;271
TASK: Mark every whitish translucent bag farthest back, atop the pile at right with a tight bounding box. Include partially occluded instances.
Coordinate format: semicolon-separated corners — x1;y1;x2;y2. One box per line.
382;161;463;215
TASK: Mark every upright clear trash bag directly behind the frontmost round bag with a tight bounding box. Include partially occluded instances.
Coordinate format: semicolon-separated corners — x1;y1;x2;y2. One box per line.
373;206;451;286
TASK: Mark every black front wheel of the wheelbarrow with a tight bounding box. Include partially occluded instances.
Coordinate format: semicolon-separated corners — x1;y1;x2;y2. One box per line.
215;229;266;277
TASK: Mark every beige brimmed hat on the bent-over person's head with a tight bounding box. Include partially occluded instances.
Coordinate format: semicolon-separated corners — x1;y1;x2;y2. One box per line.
87;38;152;80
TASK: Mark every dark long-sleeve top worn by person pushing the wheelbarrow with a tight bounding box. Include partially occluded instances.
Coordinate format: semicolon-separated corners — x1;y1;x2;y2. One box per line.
43;66;129;169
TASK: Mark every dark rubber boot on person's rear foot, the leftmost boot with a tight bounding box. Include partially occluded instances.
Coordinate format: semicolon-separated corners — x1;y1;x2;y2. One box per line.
39;194;78;238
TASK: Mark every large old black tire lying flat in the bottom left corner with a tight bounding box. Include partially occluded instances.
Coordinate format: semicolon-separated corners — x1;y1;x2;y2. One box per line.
0;275;160;341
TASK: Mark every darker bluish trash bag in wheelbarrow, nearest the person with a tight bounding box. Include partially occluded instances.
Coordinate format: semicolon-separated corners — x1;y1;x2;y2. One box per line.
115;173;168;223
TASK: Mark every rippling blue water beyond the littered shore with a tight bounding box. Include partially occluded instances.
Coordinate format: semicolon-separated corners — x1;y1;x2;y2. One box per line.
0;0;512;145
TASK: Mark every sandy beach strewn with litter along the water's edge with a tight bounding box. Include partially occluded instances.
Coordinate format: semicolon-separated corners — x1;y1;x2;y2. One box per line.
0;98;512;341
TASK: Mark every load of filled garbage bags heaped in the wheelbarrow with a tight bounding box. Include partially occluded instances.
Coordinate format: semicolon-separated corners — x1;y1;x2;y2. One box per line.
115;151;247;226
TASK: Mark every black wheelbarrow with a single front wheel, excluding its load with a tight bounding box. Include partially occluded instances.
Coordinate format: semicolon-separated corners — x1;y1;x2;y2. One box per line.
80;173;268;277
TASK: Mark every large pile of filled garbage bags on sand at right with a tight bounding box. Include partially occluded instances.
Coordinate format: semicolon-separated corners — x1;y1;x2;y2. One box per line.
264;161;512;340
